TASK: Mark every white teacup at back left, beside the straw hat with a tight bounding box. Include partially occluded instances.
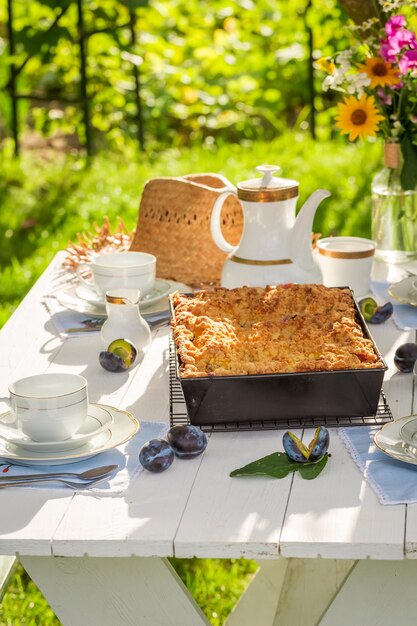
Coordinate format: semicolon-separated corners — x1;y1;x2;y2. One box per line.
77;252;156;296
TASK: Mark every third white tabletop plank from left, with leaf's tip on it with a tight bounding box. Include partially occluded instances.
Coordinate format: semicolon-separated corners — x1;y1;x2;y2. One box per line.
175;431;292;558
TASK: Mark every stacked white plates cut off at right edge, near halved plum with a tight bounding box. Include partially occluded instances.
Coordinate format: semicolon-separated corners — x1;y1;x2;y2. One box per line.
375;415;417;465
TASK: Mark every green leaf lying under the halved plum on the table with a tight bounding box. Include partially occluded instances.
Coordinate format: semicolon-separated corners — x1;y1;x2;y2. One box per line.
230;452;329;480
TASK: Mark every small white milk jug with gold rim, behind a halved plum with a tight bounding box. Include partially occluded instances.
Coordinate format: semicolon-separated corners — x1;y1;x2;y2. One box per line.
100;289;151;354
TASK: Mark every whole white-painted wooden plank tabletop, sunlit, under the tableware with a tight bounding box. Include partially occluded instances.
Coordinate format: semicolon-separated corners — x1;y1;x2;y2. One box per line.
0;251;417;559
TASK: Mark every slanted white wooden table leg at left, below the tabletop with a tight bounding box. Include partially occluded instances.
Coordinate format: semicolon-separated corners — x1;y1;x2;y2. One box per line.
20;556;210;626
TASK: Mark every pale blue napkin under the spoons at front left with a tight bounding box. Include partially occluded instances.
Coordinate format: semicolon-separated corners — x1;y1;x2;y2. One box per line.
0;422;168;496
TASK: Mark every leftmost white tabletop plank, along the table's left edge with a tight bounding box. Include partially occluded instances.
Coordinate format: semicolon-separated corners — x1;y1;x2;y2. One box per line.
0;259;73;555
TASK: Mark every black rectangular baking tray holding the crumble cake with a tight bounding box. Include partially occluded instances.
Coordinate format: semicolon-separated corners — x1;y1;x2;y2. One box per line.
171;287;387;426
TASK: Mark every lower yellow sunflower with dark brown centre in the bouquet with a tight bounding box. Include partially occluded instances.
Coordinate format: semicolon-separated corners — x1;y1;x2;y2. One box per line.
336;94;384;141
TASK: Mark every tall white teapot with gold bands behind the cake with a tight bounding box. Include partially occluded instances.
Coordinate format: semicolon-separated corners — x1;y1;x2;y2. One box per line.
210;165;330;289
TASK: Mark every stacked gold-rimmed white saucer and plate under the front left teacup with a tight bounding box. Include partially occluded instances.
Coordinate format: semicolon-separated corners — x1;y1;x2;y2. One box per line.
0;404;139;465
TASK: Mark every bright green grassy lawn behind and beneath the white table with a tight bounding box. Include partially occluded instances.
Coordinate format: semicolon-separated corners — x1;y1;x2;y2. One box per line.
0;134;381;626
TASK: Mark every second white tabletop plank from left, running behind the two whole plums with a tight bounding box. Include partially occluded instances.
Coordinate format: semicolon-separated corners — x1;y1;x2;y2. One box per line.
52;329;203;556
